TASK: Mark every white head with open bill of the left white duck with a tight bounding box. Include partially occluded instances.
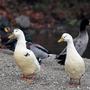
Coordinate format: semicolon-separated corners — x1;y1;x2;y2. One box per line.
8;28;24;40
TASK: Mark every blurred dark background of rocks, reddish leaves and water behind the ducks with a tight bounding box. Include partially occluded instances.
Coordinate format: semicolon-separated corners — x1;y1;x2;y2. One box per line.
0;0;90;58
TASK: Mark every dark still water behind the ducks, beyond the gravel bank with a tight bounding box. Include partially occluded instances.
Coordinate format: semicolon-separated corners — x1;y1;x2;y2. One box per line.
29;28;90;58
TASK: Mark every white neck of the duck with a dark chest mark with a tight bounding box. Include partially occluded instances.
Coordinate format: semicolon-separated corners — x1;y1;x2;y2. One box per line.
16;35;26;49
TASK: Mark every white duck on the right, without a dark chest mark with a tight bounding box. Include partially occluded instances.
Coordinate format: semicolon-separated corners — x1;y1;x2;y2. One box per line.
58;33;85;85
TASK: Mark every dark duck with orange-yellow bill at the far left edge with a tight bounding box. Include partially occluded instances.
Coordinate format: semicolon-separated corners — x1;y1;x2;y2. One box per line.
0;15;12;48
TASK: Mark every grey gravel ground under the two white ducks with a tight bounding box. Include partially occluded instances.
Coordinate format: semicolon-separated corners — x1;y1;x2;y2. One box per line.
0;50;90;90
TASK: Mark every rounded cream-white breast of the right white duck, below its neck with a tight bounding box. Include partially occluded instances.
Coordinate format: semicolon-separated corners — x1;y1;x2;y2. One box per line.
65;52;85;79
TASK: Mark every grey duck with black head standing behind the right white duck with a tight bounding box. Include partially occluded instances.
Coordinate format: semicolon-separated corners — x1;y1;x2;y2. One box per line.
56;17;90;65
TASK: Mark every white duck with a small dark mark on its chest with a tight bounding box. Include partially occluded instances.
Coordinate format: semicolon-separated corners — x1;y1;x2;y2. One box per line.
8;28;40;81
